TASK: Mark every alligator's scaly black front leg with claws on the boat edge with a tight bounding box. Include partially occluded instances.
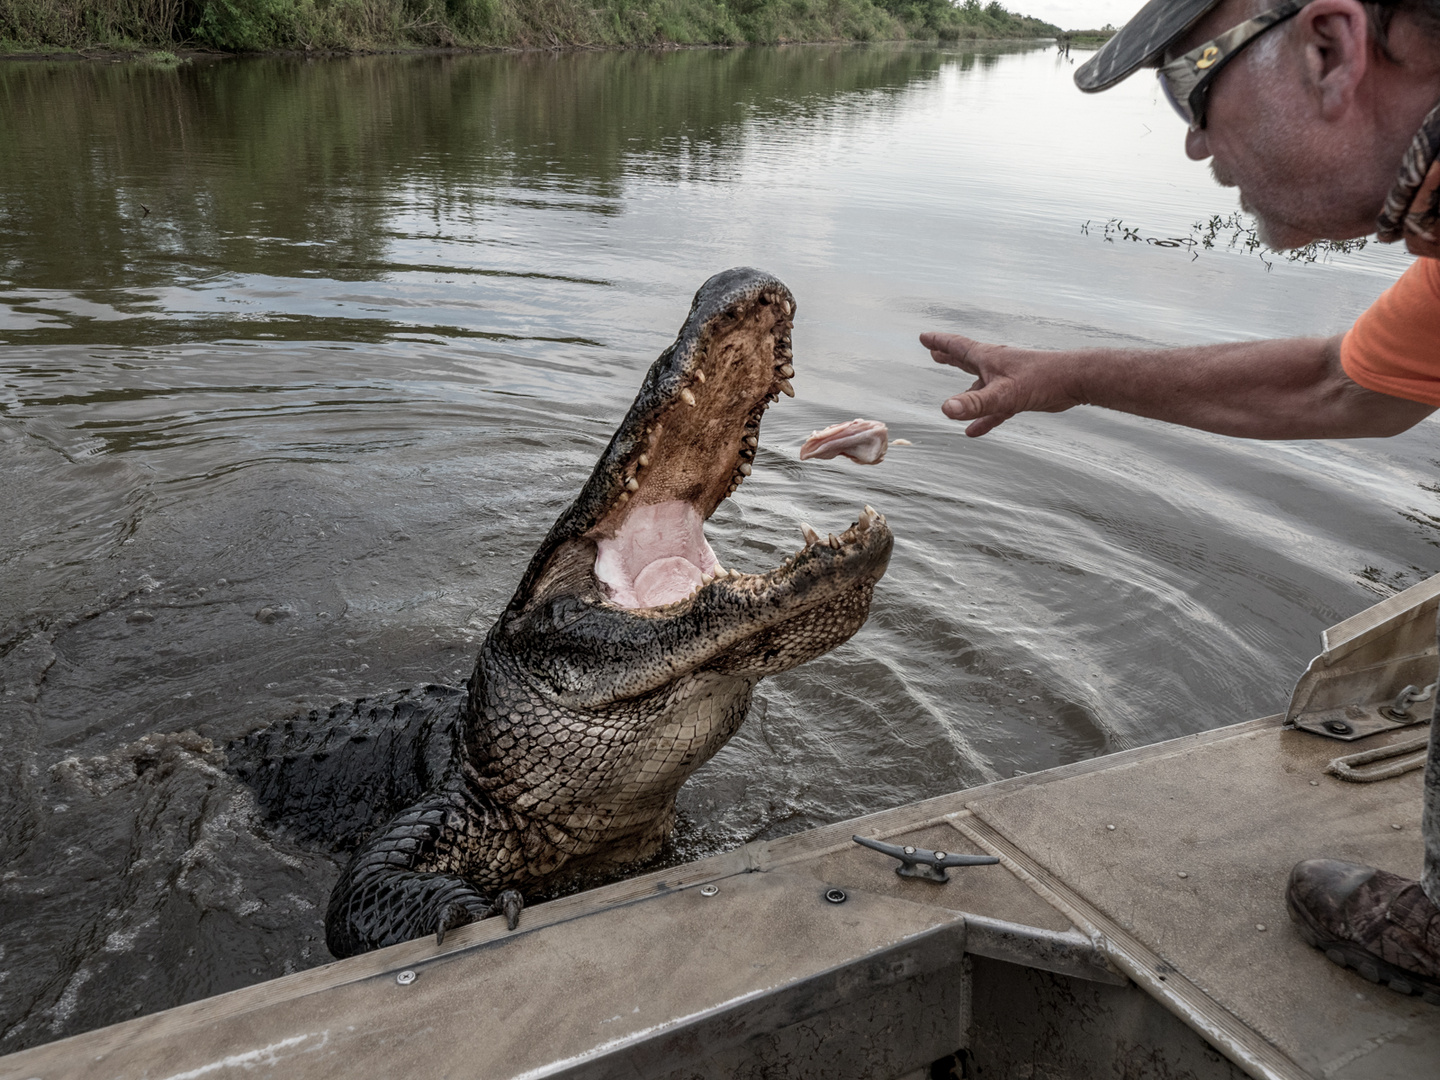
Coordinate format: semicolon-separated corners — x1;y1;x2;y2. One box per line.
325;791;524;958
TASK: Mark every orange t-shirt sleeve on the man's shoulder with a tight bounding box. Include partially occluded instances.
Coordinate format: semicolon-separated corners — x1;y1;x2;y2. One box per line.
1341;259;1440;406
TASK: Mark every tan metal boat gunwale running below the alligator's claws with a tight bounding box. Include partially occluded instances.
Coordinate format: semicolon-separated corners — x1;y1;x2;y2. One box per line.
0;871;963;1080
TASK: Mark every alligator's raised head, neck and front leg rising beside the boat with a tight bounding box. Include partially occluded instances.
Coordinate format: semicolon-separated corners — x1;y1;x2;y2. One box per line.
240;268;893;958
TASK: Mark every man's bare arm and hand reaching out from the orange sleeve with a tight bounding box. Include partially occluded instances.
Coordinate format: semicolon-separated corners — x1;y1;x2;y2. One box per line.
920;334;1434;439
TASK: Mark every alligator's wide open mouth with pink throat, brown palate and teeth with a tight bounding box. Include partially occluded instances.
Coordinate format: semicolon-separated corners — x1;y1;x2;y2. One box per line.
586;271;890;611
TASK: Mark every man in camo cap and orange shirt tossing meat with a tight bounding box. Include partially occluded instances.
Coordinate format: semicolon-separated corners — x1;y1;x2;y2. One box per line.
920;0;1440;1005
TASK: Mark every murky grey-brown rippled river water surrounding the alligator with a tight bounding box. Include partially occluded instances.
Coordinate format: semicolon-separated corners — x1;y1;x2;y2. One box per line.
0;48;1440;1051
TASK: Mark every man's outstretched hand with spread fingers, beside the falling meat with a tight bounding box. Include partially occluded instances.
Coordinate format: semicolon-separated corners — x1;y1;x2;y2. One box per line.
920;333;1086;438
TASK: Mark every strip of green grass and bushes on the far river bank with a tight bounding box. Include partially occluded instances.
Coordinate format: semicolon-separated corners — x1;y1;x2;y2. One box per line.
0;0;1058;52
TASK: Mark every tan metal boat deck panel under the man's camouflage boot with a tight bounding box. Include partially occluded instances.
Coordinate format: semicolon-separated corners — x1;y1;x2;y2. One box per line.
968;721;1440;1080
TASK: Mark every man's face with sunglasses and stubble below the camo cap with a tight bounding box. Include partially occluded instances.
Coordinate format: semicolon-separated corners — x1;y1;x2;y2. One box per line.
1166;0;1388;249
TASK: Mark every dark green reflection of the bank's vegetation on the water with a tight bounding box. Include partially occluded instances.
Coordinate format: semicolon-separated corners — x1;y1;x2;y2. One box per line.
0;45;1036;344
